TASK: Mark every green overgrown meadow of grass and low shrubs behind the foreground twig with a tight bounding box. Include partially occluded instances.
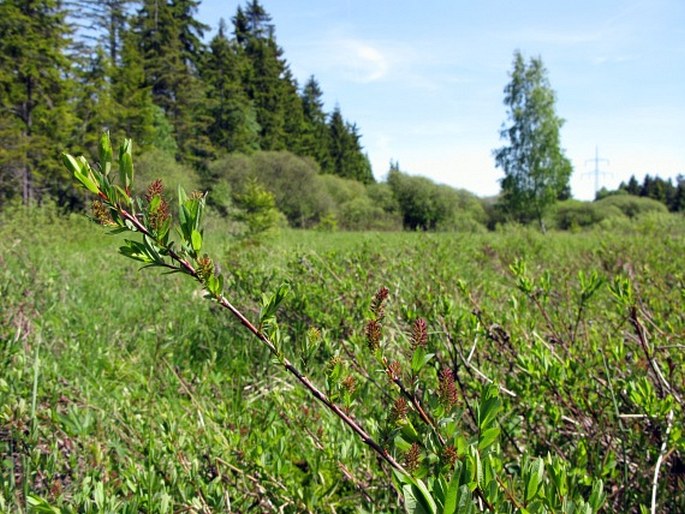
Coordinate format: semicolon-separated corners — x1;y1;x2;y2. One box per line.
0;209;685;513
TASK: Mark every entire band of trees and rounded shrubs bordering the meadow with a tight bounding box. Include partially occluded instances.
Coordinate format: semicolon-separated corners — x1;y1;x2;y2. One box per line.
0;0;685;232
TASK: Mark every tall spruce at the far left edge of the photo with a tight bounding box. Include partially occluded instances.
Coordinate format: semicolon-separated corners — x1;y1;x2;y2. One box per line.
0;0;74;204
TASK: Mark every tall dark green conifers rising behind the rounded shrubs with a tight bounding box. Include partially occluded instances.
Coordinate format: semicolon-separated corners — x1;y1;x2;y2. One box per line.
0;0;374;207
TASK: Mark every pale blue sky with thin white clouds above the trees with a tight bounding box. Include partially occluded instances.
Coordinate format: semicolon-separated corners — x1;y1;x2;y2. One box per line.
198;0;685;199
